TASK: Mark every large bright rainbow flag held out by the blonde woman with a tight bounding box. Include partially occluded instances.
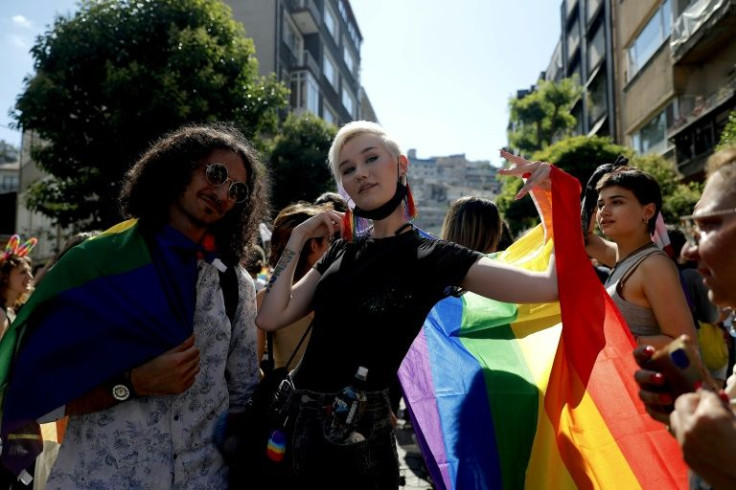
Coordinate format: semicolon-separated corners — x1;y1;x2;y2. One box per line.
399;168;687;490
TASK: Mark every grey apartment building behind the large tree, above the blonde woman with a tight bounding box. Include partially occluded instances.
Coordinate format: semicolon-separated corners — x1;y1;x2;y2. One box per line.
225;0;377;127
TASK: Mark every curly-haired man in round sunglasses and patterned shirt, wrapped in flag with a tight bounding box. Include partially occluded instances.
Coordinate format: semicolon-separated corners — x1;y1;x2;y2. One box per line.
3;125;267;489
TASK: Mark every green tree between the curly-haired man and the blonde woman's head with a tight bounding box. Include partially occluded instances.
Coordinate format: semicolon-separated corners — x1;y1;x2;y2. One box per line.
269;113;337;211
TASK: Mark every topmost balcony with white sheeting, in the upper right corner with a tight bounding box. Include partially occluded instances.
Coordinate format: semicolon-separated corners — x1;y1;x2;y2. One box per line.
670;0;736;65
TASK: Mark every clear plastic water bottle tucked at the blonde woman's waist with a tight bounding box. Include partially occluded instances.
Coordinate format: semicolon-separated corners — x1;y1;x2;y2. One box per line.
325;366;368;444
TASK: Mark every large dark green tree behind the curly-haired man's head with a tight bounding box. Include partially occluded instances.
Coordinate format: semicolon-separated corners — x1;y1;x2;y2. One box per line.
14;0;288;228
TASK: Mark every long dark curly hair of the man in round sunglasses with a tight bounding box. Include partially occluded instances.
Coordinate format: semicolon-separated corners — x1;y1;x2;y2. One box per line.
120;123;269;265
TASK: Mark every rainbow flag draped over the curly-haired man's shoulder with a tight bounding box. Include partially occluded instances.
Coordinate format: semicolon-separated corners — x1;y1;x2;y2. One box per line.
0;220;197;471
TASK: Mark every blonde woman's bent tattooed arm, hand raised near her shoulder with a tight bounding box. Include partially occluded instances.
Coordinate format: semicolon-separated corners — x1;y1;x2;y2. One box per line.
256;210;342;331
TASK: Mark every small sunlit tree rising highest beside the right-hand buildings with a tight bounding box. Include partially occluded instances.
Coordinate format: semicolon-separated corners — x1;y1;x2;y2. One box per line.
509;78;582;154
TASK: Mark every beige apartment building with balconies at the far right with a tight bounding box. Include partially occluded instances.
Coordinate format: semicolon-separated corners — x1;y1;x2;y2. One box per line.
613;0;736;180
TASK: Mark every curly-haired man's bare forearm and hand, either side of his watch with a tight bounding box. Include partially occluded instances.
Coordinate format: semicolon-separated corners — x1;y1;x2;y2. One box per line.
66;335;199;415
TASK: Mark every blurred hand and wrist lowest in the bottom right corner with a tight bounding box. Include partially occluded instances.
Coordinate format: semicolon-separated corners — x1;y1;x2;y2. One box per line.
670;390;736;488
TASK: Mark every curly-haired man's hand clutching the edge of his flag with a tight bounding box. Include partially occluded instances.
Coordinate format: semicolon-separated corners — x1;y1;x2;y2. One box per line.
130;335;199;396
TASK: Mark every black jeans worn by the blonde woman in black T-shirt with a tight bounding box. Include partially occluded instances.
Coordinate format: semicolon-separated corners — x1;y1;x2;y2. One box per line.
289;390;399;489
